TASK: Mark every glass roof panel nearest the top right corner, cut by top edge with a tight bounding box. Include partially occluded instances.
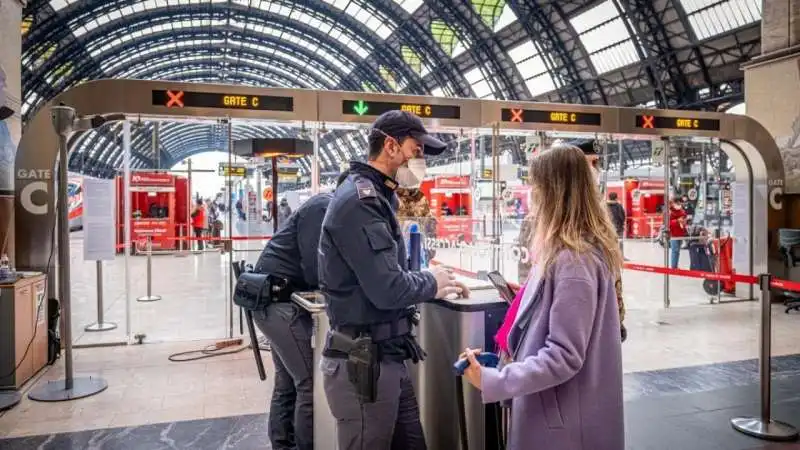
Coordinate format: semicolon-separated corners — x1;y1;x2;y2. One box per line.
681;0;762;40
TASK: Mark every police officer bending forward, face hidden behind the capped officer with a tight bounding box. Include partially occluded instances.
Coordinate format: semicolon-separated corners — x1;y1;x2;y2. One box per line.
253;173;347;450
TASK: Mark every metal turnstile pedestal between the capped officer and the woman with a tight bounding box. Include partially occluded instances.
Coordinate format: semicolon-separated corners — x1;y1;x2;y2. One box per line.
409;285;508;450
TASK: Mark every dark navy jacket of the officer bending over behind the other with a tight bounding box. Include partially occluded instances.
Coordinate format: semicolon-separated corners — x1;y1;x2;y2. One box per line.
254;194;332;290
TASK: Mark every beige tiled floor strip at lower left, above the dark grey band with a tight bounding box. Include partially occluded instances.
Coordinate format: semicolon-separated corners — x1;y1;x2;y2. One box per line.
0;342;272;435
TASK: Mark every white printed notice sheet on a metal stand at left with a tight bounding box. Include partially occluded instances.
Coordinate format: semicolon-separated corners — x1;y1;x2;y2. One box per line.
82;177;116;261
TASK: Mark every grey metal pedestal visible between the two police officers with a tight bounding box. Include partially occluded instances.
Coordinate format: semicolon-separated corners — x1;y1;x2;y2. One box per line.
292;292;338;450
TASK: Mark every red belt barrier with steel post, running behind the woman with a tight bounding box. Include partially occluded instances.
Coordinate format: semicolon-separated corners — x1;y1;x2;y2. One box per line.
431;260;800;441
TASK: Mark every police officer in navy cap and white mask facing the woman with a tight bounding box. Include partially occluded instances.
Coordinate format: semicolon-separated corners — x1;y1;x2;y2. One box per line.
319;111;469;450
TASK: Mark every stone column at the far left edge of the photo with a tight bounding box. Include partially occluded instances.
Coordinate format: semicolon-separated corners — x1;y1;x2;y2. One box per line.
0;0;23;265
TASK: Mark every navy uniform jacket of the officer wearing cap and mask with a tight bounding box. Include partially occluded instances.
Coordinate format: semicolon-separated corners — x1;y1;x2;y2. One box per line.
319;162;436;327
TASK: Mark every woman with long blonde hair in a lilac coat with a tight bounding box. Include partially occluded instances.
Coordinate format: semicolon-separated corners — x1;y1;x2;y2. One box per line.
464;146;625;450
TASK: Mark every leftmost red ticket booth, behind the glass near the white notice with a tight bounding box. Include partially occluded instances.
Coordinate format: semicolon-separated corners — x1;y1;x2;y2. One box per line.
117;172;189;250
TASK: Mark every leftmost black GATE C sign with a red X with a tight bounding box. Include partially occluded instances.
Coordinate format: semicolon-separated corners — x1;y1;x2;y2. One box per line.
153;90;294;112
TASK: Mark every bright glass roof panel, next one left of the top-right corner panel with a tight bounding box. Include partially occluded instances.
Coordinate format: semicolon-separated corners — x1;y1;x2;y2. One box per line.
570;0;640;74
